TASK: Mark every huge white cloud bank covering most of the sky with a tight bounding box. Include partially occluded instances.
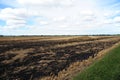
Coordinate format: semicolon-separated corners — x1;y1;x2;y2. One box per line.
0;0;120;34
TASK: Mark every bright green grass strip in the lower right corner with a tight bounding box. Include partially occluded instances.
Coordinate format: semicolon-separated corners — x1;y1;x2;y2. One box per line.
73;45;120;80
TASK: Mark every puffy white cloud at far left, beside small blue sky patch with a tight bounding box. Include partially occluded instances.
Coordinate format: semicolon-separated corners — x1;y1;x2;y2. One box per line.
0;8;27;28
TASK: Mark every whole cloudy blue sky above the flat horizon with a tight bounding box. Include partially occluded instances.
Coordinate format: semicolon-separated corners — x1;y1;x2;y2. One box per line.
0;0;120;35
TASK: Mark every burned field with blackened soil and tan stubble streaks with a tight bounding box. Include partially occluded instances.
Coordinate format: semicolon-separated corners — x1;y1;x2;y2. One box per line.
0;36;120;80
